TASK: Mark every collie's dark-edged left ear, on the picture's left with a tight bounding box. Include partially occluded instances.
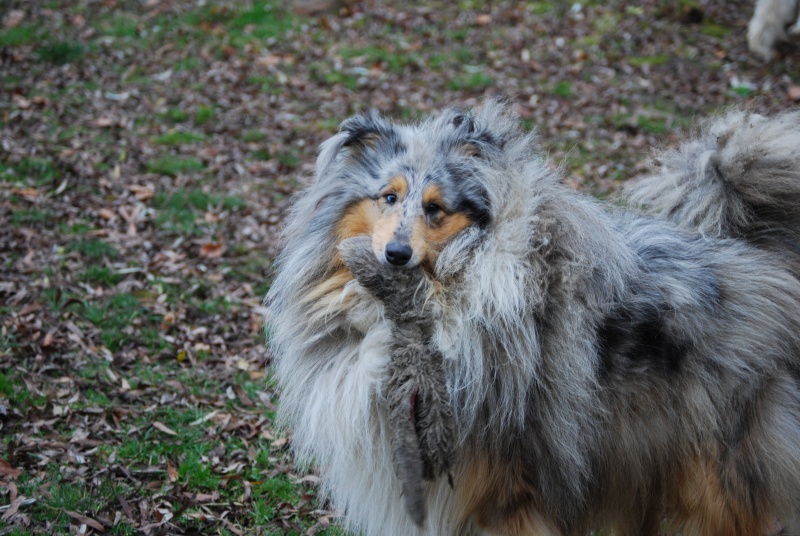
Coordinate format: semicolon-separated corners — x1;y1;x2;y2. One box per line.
316;110;392;178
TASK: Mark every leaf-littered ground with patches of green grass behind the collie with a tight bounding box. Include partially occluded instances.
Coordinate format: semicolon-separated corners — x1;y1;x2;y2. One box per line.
0;0;800;534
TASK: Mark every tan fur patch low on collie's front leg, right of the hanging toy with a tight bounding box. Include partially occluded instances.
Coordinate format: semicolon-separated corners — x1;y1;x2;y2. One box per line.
455;457;559;536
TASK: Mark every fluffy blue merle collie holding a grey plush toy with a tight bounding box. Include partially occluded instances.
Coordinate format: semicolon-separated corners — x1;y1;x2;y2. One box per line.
266;101;800;536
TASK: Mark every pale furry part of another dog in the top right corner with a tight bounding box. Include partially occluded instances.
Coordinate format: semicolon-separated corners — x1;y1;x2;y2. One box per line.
747;0;800;61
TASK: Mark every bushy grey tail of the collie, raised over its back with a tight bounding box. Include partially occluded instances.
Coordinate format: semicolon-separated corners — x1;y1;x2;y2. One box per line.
627;110;800;260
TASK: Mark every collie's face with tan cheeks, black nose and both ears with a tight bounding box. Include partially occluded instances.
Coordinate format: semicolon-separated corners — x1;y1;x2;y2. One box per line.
322;110;490;270
